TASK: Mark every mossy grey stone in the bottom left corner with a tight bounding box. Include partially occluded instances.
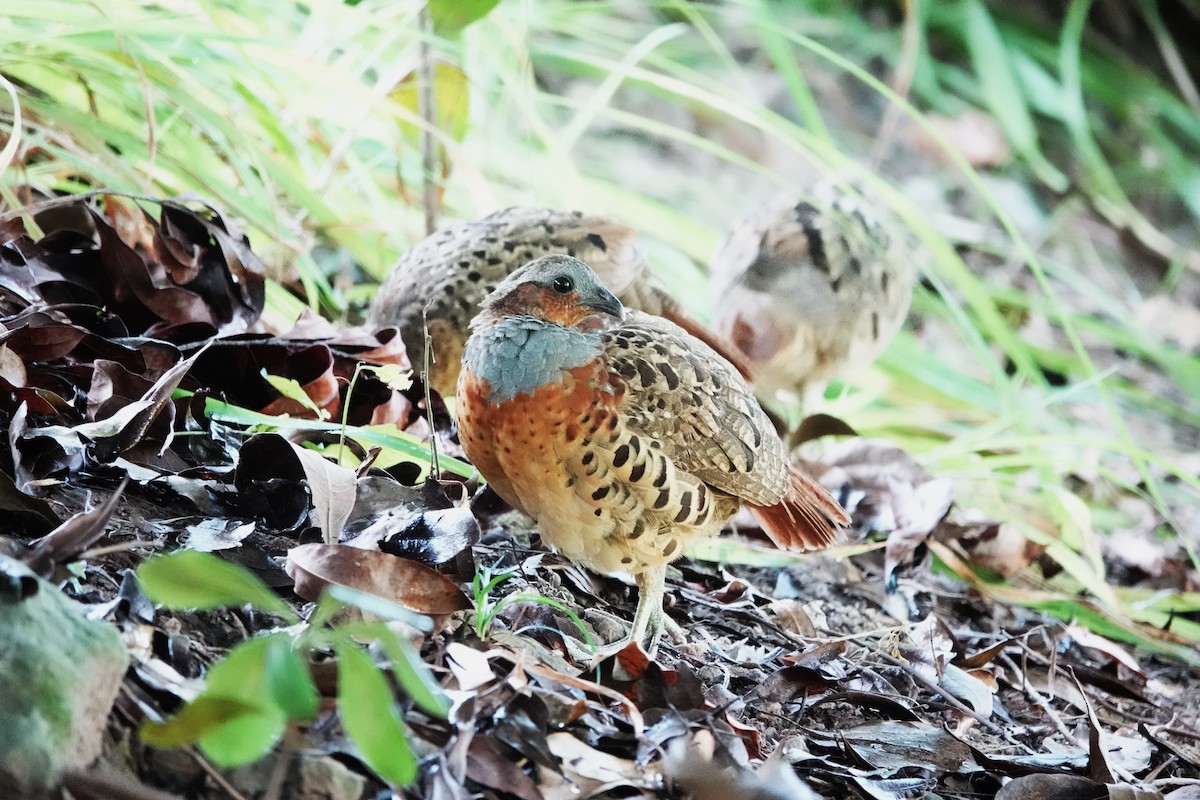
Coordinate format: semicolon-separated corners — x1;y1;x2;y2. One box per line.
0;555;130;796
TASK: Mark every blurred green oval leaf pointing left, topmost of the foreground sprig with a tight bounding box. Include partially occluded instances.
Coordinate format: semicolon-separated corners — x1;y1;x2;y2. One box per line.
137;551;300;624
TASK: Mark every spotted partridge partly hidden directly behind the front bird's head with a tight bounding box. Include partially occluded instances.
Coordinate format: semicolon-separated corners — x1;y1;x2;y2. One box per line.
367;207;737;397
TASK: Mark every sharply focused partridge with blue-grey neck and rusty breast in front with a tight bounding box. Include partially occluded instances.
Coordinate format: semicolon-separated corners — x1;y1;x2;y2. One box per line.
457;255;848;655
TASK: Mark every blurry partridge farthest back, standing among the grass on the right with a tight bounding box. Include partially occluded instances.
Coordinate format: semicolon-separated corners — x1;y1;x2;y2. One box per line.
712;182;917;412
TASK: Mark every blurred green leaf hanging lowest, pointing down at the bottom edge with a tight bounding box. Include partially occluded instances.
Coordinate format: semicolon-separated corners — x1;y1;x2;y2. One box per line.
336;642;416;786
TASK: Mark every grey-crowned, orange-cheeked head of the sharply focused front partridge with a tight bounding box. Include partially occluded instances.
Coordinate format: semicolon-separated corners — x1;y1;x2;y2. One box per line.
481;255;625;329
